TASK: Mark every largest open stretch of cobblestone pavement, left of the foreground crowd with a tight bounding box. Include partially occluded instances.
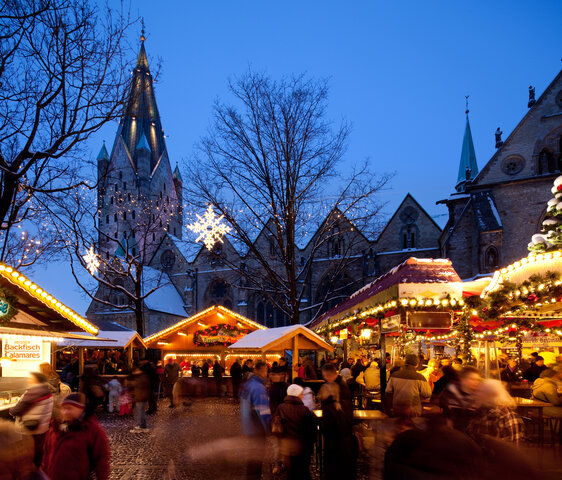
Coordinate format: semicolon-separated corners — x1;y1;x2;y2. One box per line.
100;398;252;480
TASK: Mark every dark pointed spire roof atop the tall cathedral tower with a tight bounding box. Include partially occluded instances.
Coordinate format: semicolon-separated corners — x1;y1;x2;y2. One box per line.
117;30;166;171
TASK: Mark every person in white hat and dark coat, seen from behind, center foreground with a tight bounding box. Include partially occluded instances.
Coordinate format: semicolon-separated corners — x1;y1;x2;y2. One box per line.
277;384;316;480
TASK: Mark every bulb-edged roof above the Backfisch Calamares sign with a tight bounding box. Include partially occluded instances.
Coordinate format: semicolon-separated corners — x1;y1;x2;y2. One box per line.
0;263;99;335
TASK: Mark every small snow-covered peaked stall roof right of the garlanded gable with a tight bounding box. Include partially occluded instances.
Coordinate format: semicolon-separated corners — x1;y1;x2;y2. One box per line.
229;325;334;352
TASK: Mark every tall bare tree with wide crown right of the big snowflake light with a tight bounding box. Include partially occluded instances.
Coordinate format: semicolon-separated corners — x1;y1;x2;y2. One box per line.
185;72;389;323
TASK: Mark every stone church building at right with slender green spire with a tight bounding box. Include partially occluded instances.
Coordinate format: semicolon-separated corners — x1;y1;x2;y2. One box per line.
439;72;562;279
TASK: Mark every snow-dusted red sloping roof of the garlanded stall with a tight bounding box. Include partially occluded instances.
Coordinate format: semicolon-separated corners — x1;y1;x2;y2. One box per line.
310;257;461;328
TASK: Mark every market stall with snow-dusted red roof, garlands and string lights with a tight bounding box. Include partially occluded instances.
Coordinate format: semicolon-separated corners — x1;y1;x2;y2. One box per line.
311;257;464;385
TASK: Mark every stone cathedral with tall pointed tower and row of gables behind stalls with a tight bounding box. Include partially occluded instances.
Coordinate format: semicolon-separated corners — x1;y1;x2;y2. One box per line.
87;42;441;334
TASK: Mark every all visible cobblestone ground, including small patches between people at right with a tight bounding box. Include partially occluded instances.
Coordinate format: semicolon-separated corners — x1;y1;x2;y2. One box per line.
100;398;562;480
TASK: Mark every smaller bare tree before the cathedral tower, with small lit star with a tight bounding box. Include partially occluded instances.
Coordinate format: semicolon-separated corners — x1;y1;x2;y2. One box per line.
51;187;174;336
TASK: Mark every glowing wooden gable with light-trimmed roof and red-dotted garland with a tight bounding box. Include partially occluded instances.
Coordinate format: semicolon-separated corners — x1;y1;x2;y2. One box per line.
144;305;266;369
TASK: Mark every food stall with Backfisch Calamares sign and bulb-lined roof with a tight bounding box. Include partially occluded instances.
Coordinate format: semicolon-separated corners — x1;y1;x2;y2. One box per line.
0;264;99;412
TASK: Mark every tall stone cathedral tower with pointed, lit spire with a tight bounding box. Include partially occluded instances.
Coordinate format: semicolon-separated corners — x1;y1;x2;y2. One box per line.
98;35;183;264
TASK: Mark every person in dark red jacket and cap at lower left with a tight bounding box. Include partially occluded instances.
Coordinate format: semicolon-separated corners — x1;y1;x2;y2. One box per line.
42;393;110;480
